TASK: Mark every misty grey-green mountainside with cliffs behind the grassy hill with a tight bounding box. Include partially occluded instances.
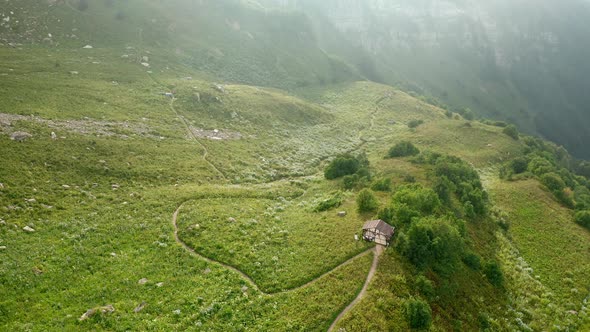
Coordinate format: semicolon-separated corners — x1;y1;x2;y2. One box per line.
267;0;590;157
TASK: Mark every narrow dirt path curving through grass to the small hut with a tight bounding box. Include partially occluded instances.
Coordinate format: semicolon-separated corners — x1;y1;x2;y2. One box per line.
172;202;379;298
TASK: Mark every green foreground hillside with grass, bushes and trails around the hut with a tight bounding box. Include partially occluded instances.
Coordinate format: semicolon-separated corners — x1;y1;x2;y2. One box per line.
0;0;590;331
